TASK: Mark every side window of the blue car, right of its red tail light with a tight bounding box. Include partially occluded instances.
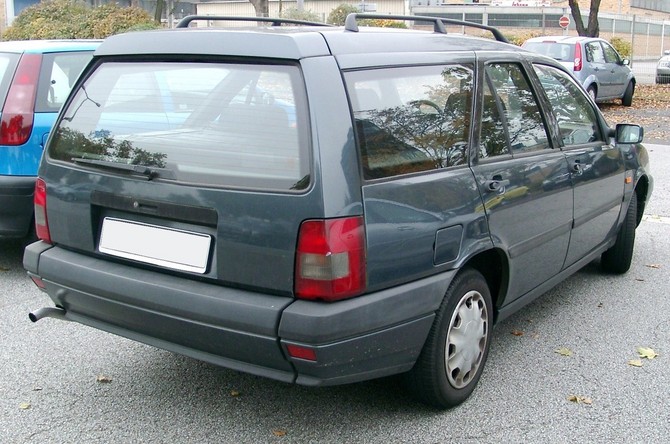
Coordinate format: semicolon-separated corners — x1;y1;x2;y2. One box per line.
35;51;93;113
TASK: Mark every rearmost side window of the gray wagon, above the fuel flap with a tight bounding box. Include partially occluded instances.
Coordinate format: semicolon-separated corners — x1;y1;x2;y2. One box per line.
345;65;473;179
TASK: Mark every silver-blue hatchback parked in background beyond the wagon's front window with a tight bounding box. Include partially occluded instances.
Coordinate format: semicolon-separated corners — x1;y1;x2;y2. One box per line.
522;36;635;106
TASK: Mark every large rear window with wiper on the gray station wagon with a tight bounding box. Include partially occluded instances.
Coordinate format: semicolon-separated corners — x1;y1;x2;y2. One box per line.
48;62;310;191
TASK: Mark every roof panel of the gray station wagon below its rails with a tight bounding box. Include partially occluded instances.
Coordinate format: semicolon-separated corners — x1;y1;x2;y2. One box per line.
96;26;518;60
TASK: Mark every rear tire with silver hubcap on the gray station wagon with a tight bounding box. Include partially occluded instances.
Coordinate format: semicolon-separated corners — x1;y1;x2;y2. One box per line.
406;269;493;409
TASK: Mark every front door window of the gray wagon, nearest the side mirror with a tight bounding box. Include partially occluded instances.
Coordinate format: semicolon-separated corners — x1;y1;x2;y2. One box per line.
534;65;603;147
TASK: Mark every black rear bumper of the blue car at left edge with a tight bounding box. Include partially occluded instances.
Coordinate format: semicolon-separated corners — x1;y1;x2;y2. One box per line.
0;176;35;237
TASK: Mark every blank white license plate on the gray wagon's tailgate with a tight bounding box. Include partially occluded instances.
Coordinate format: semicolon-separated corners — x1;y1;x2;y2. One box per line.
99;217;211;273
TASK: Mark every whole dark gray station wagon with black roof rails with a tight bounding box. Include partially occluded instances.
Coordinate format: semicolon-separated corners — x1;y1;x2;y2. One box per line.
24;14;653;408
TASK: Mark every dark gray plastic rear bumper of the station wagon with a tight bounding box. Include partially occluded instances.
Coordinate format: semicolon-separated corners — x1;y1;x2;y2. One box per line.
24;242;449;385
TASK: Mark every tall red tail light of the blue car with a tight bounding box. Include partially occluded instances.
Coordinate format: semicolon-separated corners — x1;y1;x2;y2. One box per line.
0;54;42;145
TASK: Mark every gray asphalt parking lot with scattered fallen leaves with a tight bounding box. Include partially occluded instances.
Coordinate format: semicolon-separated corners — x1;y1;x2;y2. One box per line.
0;145;670;443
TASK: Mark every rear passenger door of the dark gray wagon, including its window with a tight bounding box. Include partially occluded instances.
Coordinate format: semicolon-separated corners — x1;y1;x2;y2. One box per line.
471;63;572;303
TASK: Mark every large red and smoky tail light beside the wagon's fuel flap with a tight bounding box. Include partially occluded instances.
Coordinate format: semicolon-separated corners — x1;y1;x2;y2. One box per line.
295;217;366;301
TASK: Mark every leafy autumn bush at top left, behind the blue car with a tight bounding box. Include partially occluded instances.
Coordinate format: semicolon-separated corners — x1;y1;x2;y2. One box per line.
2;0;160;40
